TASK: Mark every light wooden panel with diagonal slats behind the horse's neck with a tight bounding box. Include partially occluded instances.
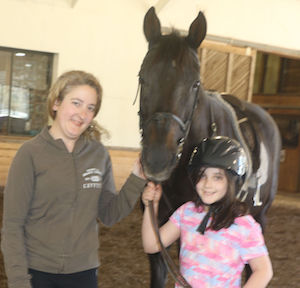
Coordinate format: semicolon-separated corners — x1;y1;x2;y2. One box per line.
198;41;256;101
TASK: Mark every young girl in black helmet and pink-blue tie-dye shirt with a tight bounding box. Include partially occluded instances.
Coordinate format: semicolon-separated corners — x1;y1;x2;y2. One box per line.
142;136;273;288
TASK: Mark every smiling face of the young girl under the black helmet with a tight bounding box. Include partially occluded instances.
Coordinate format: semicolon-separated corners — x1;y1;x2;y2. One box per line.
196;167;228;205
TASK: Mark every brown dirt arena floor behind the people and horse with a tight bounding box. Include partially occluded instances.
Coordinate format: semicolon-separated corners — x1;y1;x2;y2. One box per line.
0;189;300;288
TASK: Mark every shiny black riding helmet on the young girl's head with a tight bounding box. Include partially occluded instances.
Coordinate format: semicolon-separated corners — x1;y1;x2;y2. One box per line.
189;136;248;178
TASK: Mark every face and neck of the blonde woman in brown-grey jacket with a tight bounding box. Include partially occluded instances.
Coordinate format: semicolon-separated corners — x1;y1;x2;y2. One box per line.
51;85;97;141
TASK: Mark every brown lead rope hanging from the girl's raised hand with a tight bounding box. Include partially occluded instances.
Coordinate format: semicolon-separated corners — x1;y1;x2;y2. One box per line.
149;201;192;288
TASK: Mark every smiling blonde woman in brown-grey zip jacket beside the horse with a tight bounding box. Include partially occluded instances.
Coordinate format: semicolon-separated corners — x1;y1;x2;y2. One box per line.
1;71;146;288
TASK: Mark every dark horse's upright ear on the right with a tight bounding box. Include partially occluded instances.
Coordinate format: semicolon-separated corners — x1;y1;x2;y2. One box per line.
186;11;207;49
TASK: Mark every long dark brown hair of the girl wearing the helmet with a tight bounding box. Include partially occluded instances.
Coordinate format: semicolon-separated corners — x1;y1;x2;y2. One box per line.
190;167;249;231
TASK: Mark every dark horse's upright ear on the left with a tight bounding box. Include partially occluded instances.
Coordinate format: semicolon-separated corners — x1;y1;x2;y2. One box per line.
144;7;161;45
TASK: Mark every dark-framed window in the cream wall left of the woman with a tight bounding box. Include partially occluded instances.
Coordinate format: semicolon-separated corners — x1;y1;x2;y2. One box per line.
0;47;53;135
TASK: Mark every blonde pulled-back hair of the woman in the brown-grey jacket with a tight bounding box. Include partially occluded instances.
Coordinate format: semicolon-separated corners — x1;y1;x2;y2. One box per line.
47;70;107;140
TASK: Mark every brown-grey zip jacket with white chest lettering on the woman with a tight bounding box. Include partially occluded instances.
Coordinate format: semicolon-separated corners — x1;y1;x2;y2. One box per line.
1;127;146;288
